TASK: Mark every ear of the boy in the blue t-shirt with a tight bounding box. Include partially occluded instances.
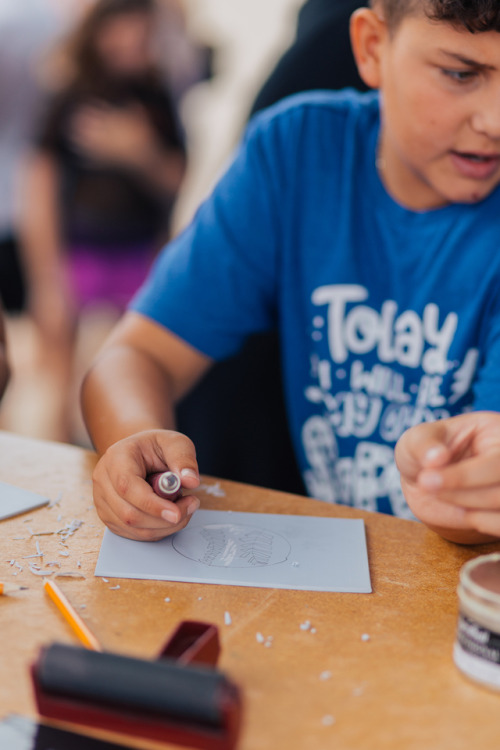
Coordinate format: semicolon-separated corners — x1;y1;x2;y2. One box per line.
350;8;388;89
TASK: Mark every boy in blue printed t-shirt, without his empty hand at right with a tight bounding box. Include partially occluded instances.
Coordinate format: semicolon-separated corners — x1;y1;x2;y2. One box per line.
83;0;500;541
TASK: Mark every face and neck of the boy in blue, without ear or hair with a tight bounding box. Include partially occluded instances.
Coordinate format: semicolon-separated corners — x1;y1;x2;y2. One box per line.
379;14;500;210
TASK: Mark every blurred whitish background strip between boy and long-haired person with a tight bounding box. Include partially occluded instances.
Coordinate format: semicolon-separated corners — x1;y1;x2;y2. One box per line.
175;0;303;229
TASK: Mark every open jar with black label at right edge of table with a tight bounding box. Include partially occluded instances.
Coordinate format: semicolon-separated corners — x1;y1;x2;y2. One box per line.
453;552;500;691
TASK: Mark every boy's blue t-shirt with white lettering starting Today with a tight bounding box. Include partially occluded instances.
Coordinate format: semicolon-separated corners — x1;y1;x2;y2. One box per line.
133;91;500;518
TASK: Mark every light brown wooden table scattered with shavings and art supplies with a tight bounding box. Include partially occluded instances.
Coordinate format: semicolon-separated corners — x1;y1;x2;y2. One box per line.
0;433;500;750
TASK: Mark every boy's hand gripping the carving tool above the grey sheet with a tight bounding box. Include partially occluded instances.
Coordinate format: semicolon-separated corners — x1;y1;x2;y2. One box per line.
92;430;200;542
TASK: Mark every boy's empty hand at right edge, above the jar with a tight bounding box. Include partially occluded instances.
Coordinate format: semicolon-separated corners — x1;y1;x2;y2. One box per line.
396;418;500;544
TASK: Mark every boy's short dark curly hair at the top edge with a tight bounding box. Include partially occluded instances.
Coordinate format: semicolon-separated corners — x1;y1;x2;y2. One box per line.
371;0;500;33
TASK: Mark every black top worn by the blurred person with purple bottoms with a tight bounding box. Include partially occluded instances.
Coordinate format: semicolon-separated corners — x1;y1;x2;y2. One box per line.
37;76;184;249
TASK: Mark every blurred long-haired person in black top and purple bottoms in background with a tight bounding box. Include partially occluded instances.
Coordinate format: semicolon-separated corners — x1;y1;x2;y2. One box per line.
18;0;185;440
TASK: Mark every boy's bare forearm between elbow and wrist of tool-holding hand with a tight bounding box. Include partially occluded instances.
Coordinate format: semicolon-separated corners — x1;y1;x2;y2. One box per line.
82;346;180;454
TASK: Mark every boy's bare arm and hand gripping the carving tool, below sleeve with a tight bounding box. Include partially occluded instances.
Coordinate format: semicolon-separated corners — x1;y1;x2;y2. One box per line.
82;312;211;541
